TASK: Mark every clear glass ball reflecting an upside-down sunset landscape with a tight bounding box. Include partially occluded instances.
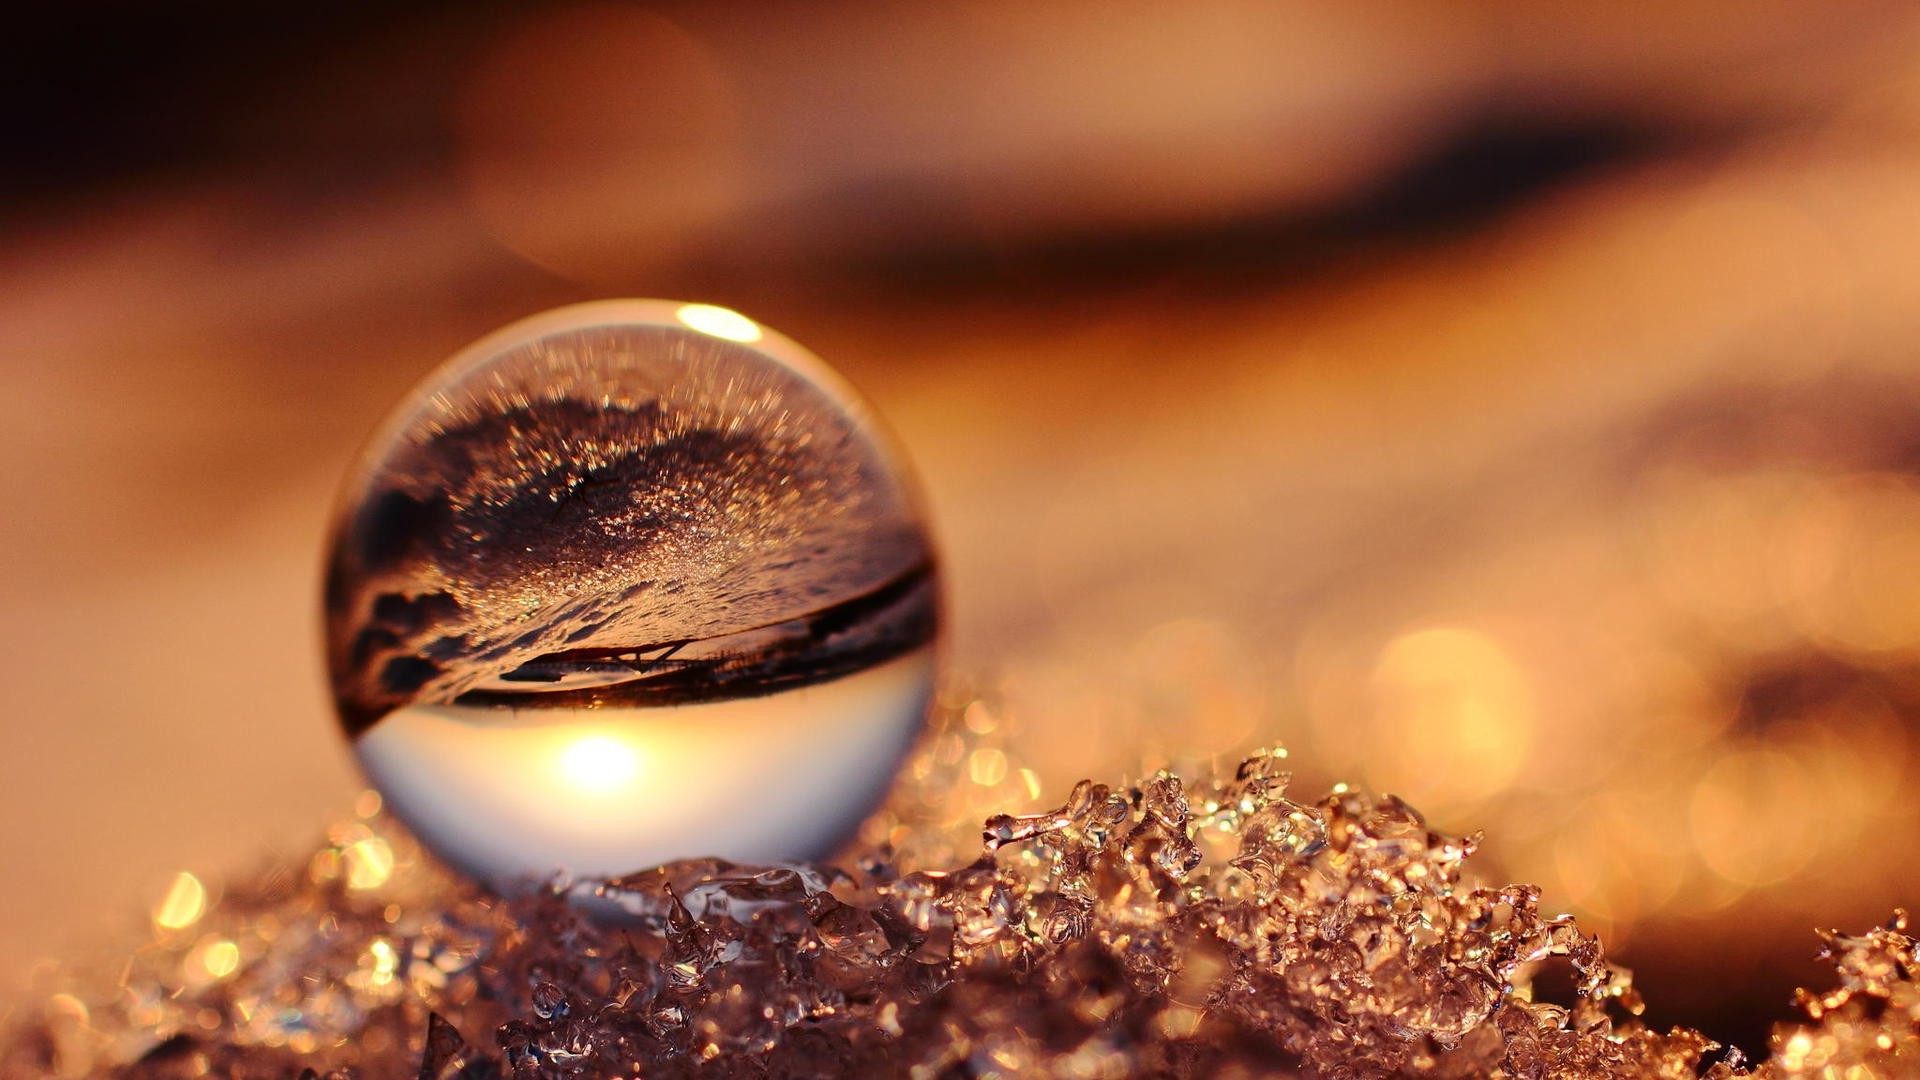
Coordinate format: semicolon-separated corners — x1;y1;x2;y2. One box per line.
326;302;937;890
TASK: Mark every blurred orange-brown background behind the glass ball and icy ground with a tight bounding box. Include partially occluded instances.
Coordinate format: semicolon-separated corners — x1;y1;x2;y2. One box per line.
0;0;1920;1049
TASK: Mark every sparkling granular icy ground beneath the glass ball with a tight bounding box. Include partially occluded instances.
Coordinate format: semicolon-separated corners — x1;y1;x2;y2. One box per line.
0;701;1920;1078
